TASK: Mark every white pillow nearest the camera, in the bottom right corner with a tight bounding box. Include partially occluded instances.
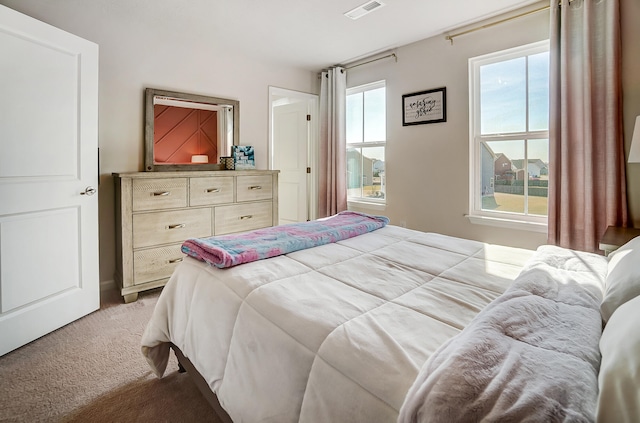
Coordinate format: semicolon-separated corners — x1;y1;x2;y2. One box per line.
597;297;640;423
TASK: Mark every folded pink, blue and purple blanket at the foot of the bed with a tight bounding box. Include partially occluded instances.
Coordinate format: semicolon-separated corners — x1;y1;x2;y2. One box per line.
182;211;389;268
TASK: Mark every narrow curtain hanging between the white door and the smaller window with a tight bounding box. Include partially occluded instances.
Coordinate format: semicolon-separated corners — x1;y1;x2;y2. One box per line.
318;67;347;217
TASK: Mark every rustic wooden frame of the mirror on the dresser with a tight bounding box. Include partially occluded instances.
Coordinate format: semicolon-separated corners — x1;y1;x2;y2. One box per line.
144;88;240;172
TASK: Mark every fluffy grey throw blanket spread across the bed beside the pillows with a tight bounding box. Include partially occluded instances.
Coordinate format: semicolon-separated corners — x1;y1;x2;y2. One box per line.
398;246;606;423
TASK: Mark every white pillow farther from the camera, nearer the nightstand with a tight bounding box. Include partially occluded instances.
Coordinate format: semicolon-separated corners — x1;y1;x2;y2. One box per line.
600;237;640;322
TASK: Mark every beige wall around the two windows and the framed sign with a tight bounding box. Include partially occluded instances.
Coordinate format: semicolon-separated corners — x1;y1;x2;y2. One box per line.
347;0;640;248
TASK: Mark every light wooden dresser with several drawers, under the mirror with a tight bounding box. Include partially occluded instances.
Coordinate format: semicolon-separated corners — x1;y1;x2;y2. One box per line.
113;170;278;303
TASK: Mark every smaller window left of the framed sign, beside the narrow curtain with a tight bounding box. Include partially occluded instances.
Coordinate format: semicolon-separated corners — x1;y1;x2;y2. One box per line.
346;81;387;203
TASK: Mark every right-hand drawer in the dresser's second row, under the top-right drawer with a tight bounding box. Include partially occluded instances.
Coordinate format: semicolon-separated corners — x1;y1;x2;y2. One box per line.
214;201;273;235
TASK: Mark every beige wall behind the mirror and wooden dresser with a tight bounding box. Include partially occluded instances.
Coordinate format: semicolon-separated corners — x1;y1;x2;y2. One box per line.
0;0;317;282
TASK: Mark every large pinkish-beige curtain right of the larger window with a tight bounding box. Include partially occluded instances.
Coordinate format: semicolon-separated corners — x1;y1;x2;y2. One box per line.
548;0;627;252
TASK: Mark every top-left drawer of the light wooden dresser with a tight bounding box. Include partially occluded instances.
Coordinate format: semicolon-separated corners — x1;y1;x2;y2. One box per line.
133;178;187;211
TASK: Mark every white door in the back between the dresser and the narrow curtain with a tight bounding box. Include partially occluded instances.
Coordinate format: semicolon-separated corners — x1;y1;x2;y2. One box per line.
270;88;317;224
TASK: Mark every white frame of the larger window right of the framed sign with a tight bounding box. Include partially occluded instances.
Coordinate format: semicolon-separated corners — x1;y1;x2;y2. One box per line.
467;40;550;232
